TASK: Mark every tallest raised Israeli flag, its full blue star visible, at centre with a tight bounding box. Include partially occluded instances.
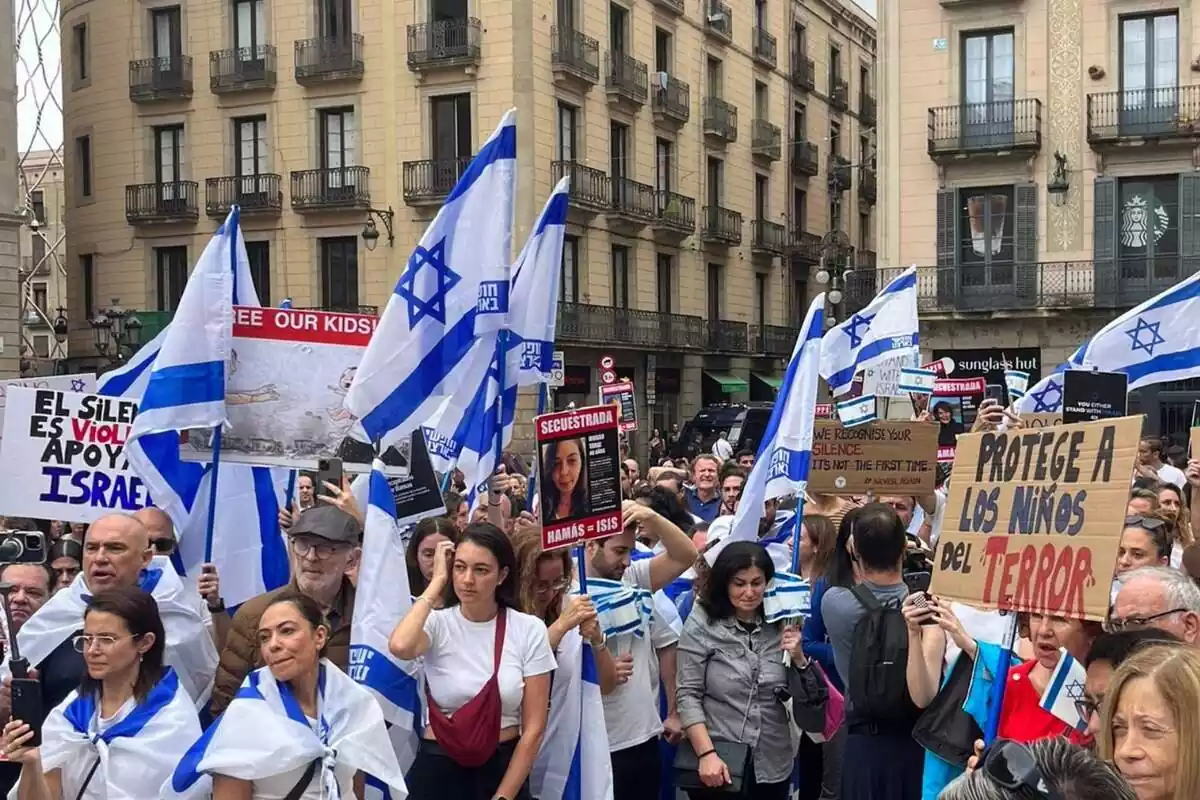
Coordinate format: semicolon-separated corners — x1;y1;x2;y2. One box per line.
346;109;517;443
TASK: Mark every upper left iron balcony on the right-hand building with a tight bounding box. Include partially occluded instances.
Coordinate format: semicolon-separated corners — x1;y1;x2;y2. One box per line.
929;98;1042;161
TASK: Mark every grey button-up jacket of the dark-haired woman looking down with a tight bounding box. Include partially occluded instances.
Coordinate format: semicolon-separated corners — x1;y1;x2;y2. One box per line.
676;602;796;783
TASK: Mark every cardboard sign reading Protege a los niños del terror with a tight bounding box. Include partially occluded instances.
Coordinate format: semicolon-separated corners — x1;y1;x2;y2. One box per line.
930;416;1142;621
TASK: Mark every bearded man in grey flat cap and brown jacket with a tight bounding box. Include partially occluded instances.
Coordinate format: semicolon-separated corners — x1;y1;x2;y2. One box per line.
212;506;362;715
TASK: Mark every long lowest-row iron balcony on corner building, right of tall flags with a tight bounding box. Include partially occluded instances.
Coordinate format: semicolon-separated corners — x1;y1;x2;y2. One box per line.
556;302;708;350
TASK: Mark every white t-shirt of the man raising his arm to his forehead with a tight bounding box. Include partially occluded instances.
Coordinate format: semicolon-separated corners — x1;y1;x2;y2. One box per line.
604;559;679;751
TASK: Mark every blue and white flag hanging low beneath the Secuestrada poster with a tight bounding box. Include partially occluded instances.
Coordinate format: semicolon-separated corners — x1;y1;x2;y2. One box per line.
529;628;614;800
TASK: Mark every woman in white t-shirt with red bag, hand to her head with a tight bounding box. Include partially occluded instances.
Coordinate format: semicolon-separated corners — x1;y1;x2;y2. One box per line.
389;523;556;800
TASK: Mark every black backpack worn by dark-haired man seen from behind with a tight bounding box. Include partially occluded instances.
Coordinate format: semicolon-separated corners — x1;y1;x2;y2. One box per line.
847;584;913;723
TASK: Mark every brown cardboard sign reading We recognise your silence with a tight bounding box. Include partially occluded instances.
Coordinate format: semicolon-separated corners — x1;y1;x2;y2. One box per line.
809;420;937;494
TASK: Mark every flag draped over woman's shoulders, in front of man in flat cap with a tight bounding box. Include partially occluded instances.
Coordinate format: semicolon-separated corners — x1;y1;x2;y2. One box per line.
161;658;408;800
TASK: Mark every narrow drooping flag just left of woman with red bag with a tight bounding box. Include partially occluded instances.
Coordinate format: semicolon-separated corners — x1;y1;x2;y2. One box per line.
349;459;421;796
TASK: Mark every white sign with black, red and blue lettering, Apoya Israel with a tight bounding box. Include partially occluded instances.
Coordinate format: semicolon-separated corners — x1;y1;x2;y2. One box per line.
0;386;152;523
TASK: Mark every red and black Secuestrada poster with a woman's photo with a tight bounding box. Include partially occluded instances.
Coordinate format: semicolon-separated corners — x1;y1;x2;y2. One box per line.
534;405;622;551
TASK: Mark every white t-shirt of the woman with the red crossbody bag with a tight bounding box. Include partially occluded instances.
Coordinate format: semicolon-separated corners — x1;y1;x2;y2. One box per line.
424;606;558;728
